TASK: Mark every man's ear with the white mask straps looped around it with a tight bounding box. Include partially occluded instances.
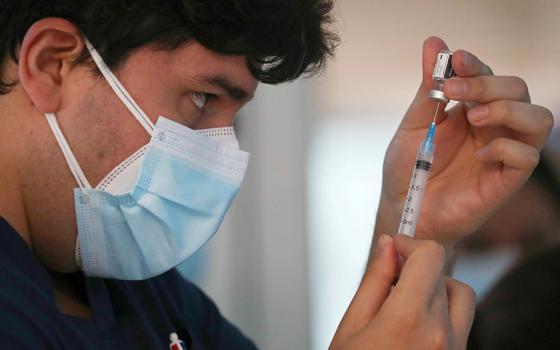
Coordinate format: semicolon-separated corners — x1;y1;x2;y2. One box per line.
18;18;84;113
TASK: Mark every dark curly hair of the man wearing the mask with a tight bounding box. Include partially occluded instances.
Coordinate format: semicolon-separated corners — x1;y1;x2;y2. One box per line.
0;0;338;94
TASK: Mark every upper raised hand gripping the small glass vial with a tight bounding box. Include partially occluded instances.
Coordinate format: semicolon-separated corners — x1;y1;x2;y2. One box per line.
376;37;553;246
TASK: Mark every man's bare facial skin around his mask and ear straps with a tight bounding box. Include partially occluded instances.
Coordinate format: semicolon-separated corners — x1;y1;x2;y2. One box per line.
21;42;257;272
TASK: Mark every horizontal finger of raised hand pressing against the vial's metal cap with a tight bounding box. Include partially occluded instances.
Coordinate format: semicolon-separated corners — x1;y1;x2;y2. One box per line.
443;75;531;103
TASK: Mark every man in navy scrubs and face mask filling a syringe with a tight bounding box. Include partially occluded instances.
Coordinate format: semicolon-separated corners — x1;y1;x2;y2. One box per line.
0;0;551;349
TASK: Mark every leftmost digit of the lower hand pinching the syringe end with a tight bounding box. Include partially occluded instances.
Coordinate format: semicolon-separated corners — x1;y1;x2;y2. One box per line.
335;235;397;338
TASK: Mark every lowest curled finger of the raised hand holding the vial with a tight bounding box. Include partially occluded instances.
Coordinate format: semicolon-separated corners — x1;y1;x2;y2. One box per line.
475;137;540;172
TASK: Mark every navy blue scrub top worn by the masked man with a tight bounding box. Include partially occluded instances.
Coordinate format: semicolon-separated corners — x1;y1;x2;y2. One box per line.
0;218;256;350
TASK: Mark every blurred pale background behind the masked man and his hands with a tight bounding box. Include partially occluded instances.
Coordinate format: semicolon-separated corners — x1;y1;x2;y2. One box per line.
177;0;560;350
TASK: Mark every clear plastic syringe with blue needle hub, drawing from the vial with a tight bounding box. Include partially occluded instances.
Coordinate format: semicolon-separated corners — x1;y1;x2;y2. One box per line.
399;103;440;237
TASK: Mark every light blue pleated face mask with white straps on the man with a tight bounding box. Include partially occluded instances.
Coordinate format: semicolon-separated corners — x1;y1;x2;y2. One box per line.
46;40;249;280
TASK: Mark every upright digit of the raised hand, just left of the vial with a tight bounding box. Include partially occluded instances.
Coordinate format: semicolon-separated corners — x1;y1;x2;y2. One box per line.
401;36;448;129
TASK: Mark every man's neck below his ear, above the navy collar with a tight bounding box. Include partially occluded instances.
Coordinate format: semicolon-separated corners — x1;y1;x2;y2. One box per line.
0;85;91;319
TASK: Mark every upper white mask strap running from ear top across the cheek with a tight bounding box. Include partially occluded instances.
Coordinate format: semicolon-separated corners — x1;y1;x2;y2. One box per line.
84;39;154;136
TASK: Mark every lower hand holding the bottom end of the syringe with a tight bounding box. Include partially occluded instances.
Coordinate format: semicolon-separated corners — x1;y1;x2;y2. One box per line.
329;235;475;350
